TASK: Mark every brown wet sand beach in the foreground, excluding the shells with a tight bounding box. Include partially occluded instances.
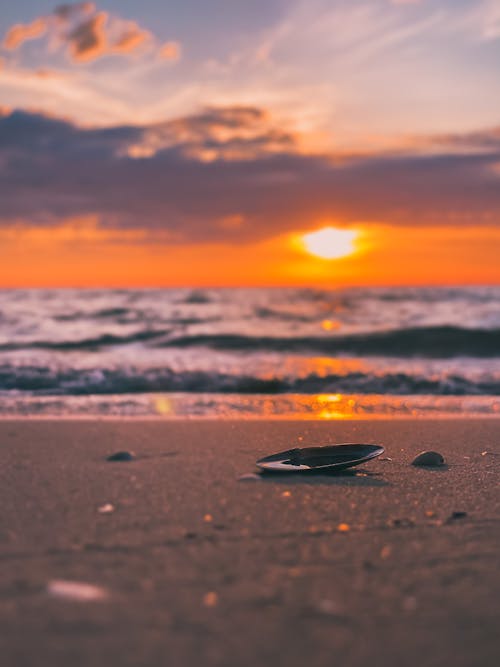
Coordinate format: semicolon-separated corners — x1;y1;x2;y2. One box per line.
0;419;500;667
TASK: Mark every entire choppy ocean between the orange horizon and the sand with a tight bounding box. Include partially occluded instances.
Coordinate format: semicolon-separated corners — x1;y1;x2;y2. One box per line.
0;287;500;419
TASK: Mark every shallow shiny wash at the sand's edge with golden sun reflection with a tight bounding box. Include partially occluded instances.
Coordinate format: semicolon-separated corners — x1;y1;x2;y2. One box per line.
0;392;500;421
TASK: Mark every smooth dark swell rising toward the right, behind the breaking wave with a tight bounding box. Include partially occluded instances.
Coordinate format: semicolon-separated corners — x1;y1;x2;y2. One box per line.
158;326;500;359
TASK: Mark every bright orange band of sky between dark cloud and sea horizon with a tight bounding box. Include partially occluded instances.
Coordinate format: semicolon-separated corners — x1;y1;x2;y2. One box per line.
0;220;500;287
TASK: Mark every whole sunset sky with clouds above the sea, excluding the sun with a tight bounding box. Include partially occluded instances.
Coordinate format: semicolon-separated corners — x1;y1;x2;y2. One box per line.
0;0;500;287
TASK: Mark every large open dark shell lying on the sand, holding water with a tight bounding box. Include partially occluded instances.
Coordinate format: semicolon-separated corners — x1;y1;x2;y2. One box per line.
257;444;384;472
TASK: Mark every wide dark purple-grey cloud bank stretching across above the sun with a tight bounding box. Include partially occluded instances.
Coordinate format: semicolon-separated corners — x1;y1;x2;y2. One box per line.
0;107;500;242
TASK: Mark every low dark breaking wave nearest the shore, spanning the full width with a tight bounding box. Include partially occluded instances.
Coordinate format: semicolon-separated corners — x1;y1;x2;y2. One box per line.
0;364;500;396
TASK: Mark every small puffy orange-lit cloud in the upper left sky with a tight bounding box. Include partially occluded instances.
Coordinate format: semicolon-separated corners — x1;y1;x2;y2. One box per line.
3;2;181;63
